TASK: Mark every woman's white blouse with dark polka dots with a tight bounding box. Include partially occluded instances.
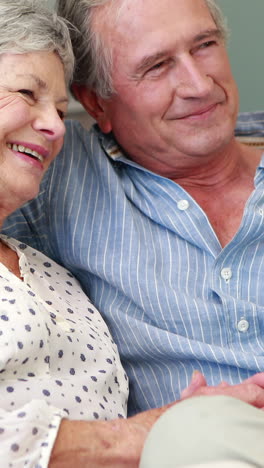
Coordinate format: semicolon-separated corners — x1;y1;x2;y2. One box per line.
0;236;128;468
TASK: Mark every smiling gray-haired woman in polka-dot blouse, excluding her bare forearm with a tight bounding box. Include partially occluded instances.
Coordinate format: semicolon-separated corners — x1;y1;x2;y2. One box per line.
0;0;128;468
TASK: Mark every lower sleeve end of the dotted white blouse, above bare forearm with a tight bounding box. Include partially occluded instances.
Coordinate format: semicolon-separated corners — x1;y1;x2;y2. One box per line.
0;400;65;468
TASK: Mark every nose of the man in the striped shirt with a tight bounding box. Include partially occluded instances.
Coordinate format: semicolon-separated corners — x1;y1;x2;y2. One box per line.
176;56;213;99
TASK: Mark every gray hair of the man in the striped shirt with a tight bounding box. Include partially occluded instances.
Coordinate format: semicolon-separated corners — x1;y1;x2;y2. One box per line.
57;0;227;99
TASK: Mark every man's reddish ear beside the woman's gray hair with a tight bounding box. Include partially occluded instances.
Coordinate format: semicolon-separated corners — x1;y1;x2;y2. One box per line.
72;84;112;133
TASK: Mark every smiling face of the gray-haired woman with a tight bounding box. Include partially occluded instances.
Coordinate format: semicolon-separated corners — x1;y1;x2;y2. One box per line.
0;52;68;207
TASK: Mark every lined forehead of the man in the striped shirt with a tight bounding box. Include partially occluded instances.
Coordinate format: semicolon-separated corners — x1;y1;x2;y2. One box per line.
93;0;215;52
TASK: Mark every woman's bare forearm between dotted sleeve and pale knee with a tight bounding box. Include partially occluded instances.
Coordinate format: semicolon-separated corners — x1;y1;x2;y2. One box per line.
49;404;172;468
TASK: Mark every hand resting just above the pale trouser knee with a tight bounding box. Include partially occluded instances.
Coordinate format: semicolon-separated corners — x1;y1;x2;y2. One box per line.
181;371;264;408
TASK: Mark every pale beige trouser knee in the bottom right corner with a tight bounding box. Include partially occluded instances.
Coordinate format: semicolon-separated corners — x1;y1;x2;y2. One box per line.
140;395;264;468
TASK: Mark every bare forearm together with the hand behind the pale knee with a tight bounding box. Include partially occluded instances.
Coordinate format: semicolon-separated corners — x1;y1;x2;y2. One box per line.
49;372;264;468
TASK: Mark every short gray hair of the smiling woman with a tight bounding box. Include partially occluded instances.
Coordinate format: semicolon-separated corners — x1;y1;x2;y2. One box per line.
0;0;74;83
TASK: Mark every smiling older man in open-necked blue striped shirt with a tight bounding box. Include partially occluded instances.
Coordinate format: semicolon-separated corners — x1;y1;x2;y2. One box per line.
4;0;264;466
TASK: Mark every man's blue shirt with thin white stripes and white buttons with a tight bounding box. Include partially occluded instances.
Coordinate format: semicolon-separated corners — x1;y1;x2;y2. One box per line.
5;113;264;414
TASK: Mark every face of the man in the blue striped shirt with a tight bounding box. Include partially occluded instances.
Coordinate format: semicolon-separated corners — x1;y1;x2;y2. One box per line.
94;0;238;176
